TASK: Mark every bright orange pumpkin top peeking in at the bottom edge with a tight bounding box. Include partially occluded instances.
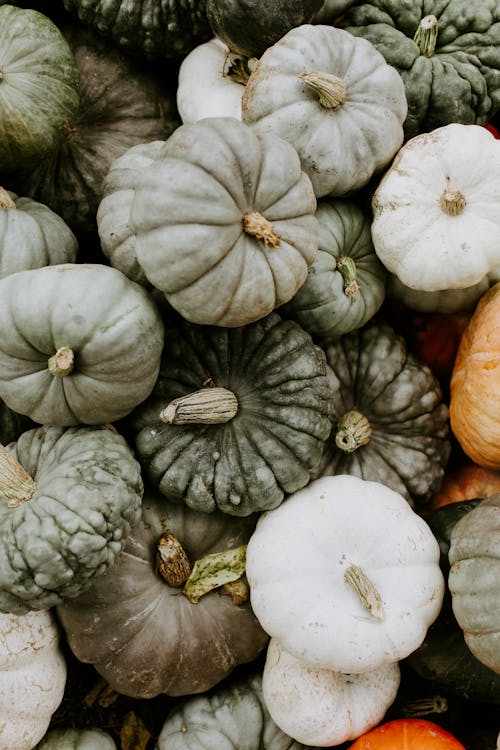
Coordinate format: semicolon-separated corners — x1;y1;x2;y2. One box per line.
350;719;465;750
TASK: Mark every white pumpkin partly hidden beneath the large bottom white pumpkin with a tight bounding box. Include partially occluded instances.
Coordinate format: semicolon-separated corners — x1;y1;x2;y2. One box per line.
262;638;401;747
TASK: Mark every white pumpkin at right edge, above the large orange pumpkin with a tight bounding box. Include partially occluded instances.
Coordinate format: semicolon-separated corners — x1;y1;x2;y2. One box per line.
372;123;500;292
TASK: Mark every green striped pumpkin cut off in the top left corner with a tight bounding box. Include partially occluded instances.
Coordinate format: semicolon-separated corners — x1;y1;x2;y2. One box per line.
0;5;80;172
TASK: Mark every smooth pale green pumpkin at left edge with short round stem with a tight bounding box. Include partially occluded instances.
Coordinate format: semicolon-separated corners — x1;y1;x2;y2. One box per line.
0;263;163;426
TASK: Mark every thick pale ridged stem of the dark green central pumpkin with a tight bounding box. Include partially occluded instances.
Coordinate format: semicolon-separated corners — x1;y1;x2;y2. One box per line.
160;387;238;424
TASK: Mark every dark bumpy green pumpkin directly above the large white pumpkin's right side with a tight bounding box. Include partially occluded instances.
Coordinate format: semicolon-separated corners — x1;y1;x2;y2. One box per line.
313;320;451;505
